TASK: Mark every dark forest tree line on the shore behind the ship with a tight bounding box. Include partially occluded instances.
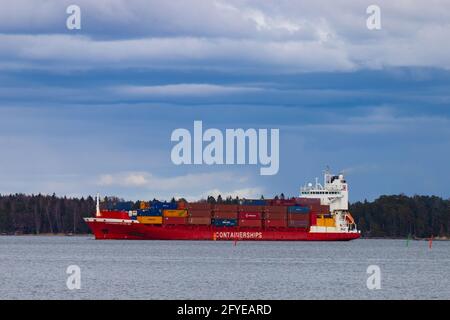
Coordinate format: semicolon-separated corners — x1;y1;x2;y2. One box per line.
0;194;450;238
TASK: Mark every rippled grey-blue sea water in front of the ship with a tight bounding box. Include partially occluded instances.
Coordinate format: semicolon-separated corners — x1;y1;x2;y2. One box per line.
0;236;450;299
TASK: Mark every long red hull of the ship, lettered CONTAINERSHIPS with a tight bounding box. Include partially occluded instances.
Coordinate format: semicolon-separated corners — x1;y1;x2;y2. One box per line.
86;218;360;241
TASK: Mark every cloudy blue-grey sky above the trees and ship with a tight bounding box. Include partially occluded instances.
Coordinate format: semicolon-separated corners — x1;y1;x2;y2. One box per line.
0;0;450;201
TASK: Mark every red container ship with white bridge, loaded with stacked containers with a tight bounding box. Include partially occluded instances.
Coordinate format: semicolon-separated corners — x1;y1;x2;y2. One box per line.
85;171;360;241
